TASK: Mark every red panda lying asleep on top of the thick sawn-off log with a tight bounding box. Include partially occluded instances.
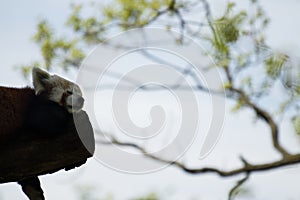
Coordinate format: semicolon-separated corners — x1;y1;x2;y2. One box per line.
0;68;84;142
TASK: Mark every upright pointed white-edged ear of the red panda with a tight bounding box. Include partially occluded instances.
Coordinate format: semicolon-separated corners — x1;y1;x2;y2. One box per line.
32;67;51;95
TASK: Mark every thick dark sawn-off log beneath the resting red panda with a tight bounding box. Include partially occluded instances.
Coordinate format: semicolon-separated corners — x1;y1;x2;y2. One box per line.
0;111;95;183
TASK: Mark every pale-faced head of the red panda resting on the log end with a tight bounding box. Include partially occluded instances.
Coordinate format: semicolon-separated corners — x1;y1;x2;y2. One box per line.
32;68;84;113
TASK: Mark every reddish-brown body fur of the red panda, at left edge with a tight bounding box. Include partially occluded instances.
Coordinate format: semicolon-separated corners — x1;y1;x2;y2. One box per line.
0;87;35;142
